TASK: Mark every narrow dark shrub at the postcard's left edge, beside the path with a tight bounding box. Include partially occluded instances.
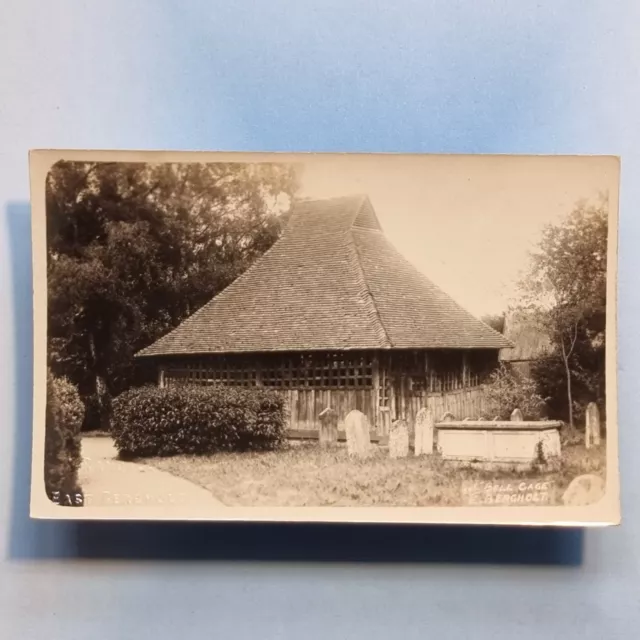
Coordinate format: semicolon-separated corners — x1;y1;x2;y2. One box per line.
44;372;84;506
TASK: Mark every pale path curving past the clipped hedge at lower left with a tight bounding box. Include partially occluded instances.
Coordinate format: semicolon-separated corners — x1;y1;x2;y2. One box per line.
79;437;224;508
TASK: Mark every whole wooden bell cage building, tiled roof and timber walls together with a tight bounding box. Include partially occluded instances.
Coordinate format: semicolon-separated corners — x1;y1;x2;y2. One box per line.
137;196;512;435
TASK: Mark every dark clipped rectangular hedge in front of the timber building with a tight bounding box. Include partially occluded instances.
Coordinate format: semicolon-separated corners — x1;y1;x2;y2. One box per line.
111;386;286;459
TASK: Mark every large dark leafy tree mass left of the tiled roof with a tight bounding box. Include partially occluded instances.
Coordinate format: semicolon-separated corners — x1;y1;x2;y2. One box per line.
47;162;297;428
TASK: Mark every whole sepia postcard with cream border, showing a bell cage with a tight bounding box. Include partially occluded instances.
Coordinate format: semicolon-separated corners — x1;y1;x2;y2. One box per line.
30;150;620;526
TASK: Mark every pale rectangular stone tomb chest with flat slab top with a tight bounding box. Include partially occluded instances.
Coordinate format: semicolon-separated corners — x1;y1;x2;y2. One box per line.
435;420;562;466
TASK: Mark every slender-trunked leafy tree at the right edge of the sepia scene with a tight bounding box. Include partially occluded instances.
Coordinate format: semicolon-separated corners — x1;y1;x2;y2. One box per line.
523;199;608;426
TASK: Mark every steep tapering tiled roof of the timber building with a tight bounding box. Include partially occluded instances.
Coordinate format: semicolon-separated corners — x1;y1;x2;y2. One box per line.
137;196;511;356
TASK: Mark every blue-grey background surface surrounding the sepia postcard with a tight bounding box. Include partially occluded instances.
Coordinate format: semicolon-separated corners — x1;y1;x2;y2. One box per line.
0;0;640;640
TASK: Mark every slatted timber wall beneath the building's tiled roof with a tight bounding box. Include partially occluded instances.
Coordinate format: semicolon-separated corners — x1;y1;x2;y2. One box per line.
158;349;497;435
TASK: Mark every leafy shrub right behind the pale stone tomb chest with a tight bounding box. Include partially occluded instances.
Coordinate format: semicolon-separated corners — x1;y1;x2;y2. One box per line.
485;364;546;420
